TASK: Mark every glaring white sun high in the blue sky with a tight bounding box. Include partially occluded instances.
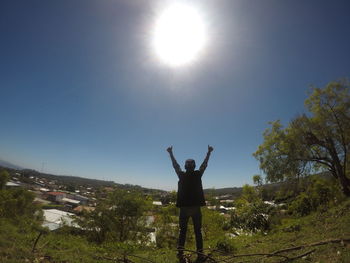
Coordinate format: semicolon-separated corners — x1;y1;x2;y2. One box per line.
153;4;206;66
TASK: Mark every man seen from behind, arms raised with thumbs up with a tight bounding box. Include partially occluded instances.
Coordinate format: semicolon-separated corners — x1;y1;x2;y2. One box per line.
167;145;214;263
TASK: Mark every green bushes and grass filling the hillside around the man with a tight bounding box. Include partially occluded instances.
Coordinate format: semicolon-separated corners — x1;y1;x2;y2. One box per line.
0;163;350;263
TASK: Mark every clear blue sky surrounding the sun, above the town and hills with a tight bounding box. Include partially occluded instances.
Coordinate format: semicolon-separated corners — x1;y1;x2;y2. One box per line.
0;0;350;190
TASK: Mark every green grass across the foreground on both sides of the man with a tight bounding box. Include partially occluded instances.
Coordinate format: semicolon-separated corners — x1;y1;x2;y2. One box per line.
0;200;350;263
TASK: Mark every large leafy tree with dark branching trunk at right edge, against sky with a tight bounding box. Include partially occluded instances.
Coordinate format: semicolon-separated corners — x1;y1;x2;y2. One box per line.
253;81;350;196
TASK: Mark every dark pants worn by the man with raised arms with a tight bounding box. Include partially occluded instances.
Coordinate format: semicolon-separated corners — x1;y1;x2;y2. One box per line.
177;206;203;255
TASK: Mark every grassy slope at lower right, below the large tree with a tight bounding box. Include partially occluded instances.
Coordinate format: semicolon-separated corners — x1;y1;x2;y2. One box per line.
215;201;350;263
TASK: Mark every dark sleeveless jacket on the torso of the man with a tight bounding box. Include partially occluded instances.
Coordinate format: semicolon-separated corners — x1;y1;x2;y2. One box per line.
176;170;205;207
